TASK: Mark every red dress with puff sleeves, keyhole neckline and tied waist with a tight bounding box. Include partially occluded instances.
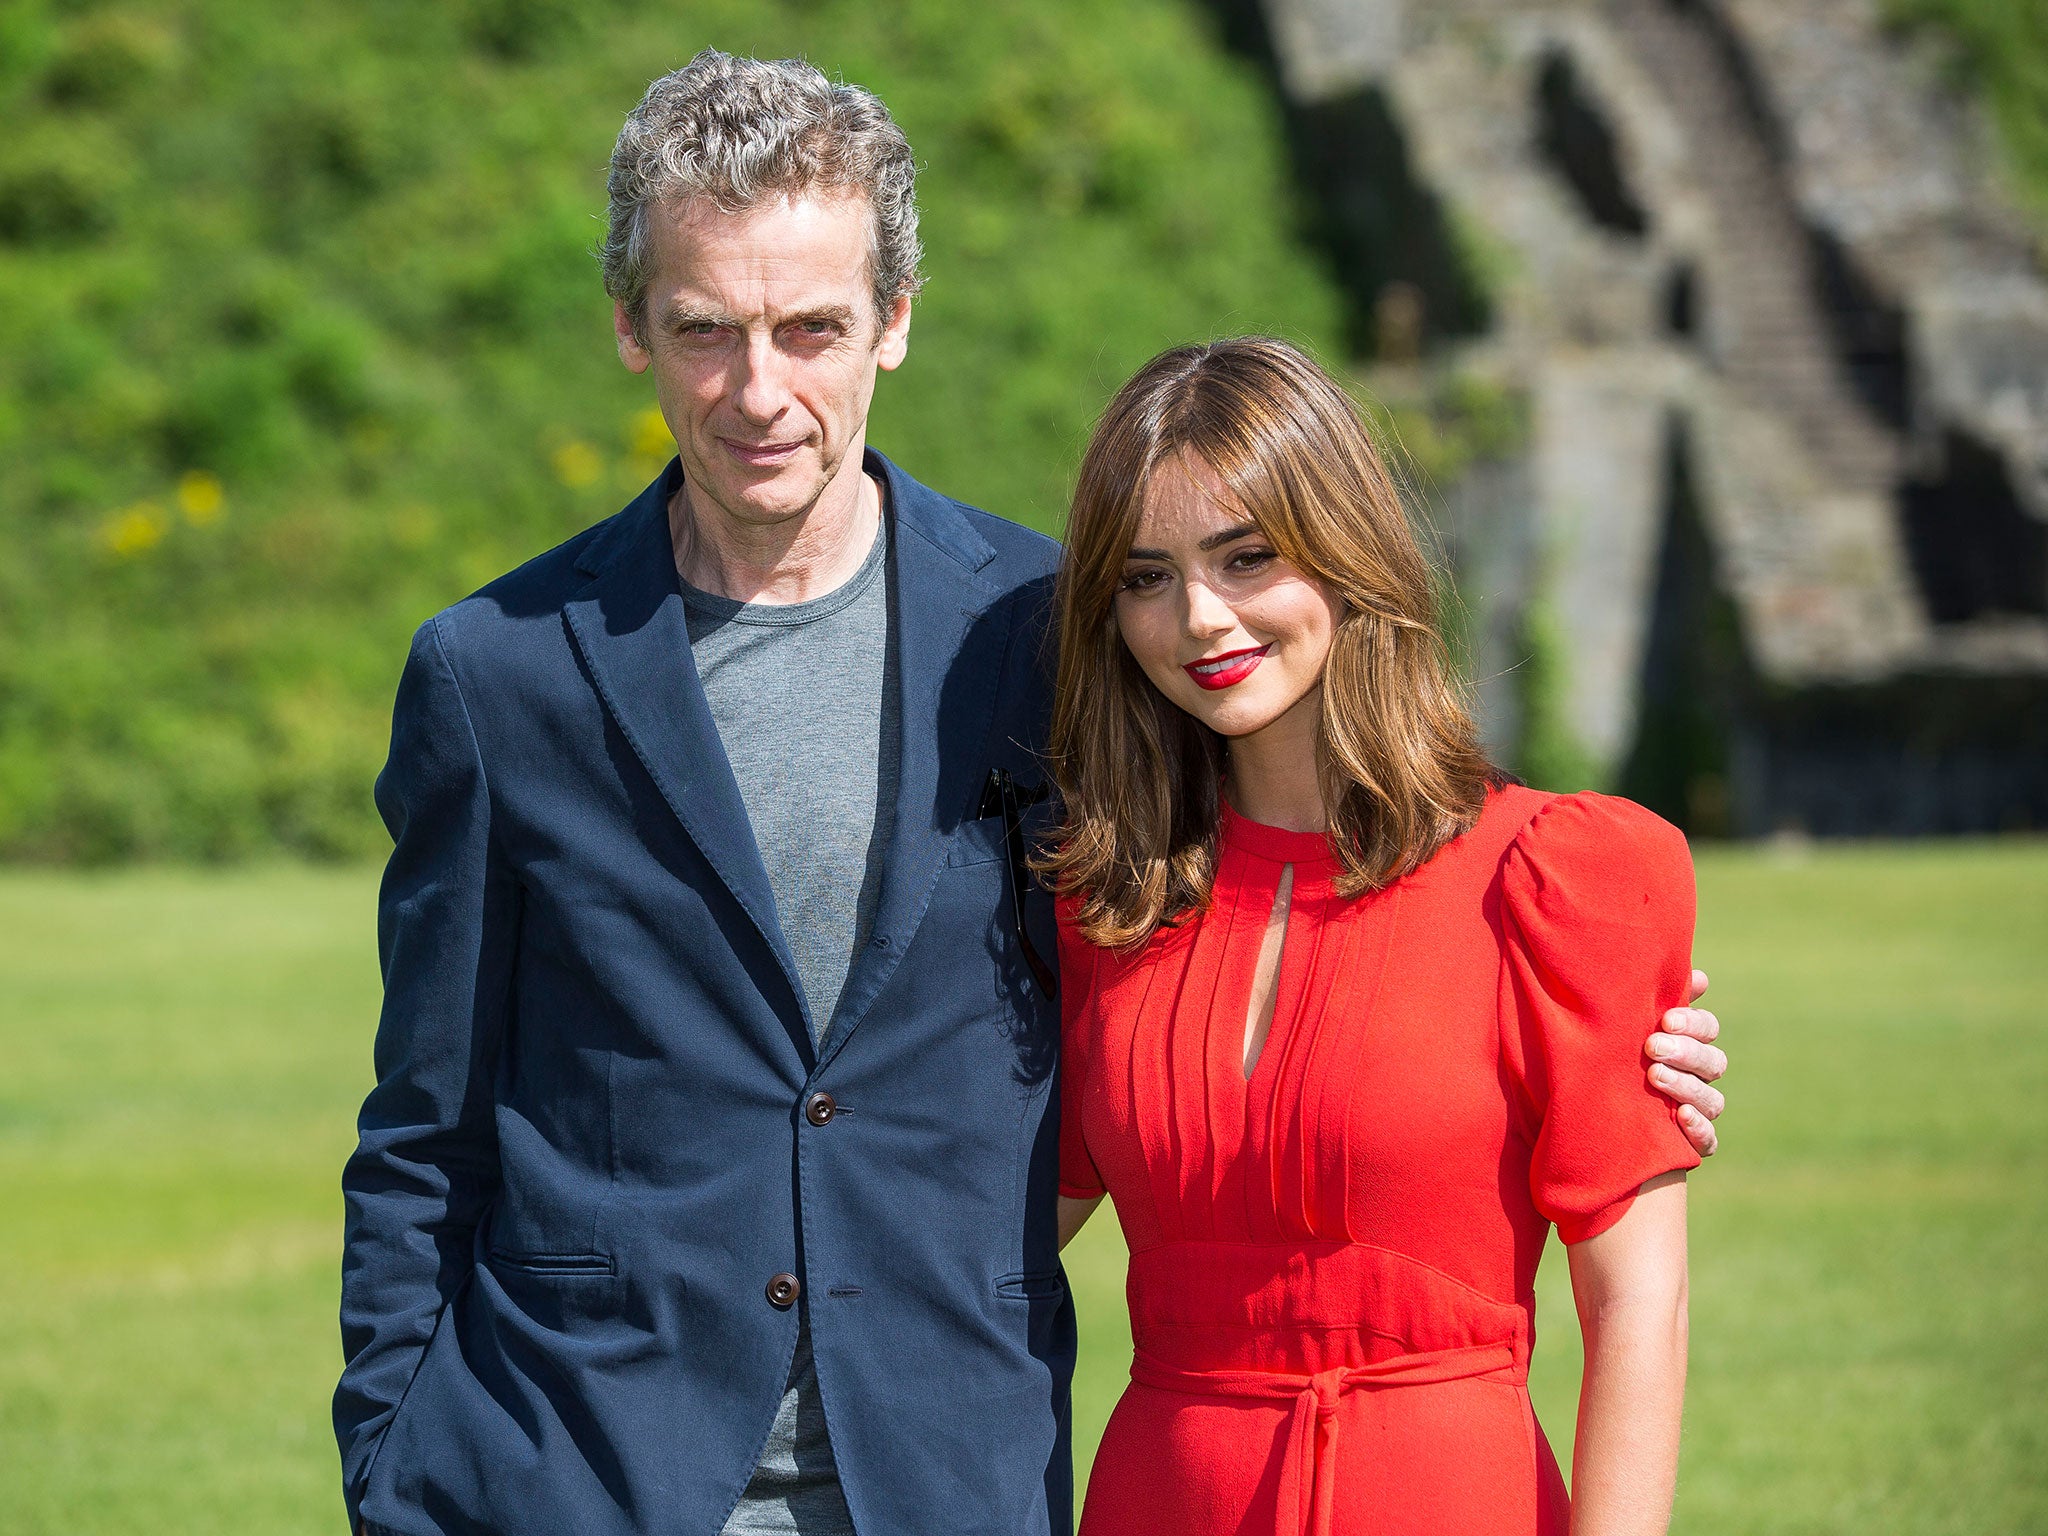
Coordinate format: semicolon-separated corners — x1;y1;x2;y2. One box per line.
1061;788;1700;1536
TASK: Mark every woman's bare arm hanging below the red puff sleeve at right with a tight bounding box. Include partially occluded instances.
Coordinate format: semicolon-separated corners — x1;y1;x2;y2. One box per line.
1556;1174;1686;1536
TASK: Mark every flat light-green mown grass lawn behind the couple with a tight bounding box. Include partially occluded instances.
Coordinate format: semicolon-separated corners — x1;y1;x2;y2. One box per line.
0;842;2048;1536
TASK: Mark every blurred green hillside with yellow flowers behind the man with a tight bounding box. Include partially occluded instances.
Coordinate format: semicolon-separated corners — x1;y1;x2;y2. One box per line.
0;0;1335;860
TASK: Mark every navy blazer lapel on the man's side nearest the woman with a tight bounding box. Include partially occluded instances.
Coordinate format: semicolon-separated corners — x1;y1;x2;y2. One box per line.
817;449;1010;1067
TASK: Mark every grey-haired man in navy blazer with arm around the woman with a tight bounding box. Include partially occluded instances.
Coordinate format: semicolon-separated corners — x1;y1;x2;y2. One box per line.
336;53;1722;1536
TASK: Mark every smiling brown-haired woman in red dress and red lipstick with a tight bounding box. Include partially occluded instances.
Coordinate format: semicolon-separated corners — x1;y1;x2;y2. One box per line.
1047;340;1698;1536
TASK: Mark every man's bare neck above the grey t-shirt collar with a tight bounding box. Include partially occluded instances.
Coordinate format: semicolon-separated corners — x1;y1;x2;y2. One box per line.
668;455;883;604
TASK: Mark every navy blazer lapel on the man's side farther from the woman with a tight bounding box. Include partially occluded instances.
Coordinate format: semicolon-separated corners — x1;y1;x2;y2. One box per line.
567;461;811;1055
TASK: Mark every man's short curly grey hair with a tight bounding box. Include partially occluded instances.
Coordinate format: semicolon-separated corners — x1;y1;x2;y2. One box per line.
598;49;924;344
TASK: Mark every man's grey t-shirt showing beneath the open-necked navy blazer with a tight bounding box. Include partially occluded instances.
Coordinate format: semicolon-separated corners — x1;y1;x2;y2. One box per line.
682;516;897;1536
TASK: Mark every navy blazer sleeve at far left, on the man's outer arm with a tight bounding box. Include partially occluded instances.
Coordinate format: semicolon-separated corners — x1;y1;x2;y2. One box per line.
334;621;518;1524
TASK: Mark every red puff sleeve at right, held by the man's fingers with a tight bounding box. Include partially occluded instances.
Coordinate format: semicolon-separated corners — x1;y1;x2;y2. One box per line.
1501;795;1700;1243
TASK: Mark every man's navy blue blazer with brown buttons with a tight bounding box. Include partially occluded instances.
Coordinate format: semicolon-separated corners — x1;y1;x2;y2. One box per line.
334;453;1073;1536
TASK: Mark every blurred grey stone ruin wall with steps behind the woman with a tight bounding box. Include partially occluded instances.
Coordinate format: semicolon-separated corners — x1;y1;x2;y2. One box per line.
1264;0;2048;829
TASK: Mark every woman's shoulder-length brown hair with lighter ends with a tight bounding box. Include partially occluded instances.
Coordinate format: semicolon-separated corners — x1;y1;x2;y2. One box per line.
1038;336;1501;948
